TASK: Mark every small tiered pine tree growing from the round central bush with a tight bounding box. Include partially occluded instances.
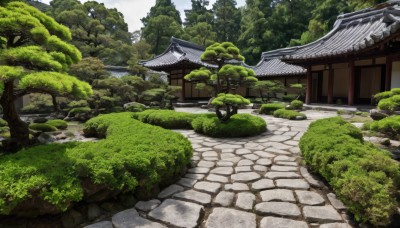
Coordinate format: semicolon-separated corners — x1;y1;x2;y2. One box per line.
185;42;257;122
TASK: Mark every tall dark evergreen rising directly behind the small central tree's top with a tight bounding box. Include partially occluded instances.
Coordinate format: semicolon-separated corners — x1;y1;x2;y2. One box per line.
213;0;241;43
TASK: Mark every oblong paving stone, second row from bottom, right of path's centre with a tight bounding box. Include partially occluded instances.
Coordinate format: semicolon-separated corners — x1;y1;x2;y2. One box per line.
255;202;301;218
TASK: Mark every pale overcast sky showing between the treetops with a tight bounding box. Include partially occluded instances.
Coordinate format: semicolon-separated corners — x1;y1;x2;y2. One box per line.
41;0;245;32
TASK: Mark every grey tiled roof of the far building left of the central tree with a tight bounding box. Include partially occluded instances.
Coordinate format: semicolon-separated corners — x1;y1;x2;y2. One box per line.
141;37;215;69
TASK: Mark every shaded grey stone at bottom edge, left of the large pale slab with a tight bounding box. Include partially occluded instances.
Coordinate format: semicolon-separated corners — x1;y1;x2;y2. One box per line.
112;209;166;228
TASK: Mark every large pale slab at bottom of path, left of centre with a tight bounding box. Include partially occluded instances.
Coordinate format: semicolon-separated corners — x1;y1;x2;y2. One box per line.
148;199;204;227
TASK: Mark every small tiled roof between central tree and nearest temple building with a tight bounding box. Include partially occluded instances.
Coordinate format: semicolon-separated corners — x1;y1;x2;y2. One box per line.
251;49;307;77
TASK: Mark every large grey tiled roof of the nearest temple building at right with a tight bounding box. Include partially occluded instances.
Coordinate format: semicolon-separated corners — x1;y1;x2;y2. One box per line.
279;0;400;62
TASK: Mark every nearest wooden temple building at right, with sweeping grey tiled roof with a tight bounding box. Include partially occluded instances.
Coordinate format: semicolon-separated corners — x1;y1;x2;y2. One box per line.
279;1;400;105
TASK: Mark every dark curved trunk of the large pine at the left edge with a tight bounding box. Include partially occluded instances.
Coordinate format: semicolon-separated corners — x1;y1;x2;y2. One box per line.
0;81;29;151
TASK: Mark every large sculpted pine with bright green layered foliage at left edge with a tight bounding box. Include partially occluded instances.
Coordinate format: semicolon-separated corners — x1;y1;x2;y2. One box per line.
0;2;92;149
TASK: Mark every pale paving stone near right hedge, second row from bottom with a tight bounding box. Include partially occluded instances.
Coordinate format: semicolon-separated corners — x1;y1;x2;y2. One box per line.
303;206;342;223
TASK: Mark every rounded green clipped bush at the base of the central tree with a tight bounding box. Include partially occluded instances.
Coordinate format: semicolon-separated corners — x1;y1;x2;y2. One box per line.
192;114;267;138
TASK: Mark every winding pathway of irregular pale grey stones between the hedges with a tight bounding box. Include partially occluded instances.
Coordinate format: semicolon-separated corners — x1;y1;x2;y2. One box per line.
87;111;351;228
